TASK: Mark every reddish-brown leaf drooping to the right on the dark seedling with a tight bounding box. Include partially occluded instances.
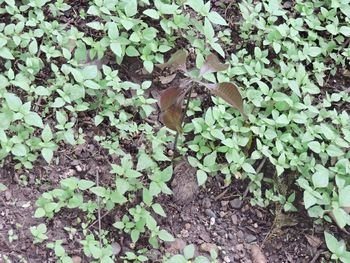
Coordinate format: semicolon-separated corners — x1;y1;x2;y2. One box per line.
203;82;247;119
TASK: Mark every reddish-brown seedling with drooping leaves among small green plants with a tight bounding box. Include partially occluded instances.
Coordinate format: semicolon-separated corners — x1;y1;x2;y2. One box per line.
157;50;246;149
